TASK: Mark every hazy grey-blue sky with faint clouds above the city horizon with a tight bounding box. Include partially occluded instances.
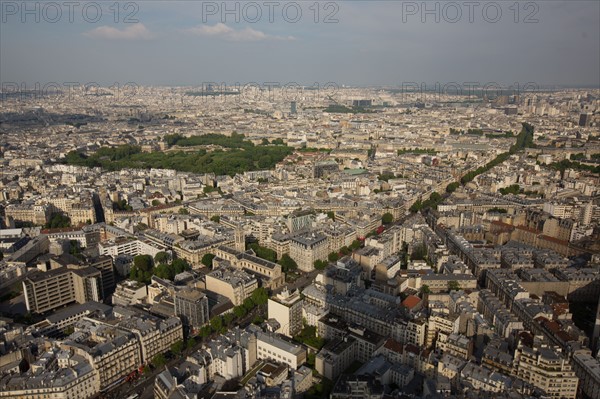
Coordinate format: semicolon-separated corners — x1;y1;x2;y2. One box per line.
0;0;600;88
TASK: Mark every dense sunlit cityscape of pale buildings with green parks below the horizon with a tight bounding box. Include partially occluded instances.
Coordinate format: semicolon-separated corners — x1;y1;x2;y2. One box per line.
0;3;600;399
